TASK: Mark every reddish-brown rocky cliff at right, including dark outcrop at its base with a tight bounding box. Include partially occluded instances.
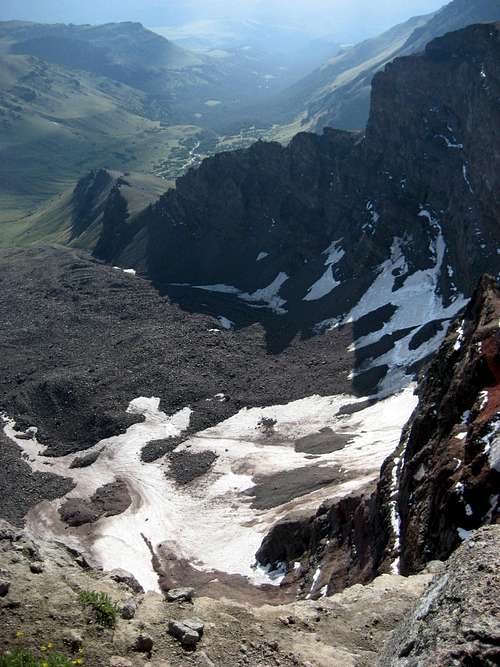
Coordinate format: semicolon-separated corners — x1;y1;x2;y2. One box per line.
257;277;500;597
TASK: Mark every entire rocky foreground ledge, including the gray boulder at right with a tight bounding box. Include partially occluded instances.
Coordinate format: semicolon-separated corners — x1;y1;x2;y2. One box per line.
0;522;500;667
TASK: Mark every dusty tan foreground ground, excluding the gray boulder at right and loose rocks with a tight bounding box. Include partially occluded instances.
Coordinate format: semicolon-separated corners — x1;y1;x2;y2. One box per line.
0;523;432;667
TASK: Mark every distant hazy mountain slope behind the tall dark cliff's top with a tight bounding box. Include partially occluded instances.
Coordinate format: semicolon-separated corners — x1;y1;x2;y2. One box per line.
276;0;500;131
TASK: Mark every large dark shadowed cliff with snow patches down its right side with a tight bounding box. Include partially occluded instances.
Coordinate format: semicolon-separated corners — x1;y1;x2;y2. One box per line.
96;24;500;389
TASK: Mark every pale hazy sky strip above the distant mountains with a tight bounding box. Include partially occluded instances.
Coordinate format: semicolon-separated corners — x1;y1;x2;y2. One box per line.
0;0;446;39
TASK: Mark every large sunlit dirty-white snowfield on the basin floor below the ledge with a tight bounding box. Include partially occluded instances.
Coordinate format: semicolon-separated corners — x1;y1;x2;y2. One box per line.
4;387;417;590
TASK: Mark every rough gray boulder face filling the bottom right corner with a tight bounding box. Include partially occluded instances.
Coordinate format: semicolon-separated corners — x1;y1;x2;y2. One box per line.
378;526;500;667
